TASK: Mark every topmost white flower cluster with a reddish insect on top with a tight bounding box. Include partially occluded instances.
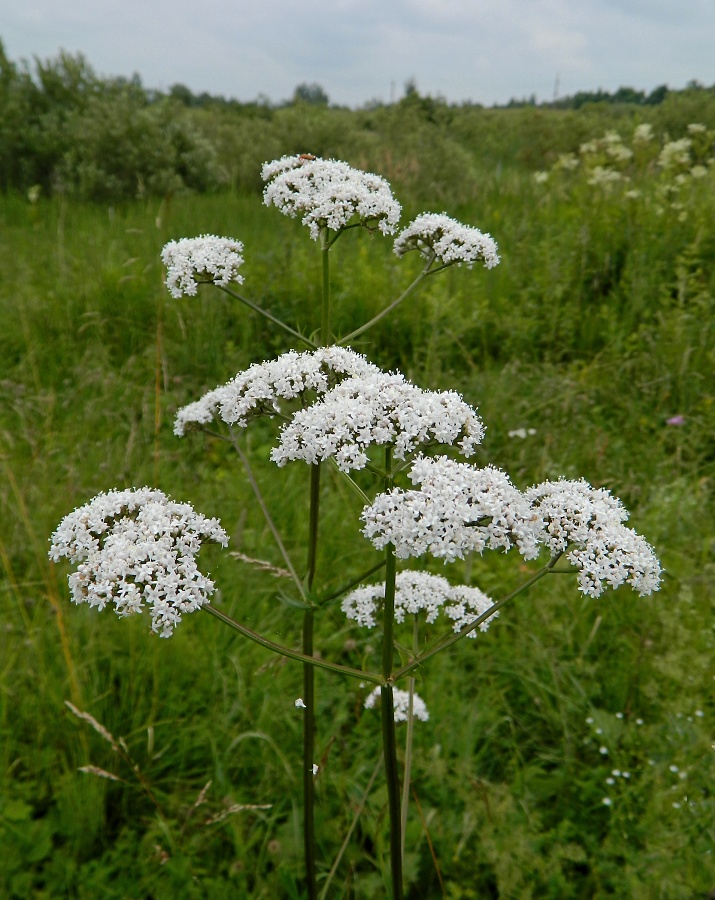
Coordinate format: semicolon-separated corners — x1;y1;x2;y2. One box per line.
261;154;401;240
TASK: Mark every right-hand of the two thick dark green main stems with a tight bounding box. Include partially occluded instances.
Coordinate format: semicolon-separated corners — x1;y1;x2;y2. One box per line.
380;447;402;900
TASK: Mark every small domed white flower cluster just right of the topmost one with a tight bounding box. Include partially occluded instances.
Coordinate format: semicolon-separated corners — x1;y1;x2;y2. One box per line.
395;213;499;269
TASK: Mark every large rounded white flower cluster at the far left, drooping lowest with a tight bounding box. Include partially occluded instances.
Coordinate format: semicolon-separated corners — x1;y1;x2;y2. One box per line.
49;487;228;637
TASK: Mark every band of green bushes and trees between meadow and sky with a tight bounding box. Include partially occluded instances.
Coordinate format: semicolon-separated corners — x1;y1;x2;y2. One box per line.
0;43;715;205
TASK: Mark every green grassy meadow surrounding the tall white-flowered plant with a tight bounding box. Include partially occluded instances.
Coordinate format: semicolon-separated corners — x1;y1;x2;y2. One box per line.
0;100;715;900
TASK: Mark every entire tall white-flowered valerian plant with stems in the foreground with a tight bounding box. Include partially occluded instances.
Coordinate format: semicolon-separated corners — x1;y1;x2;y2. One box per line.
50;154;660;900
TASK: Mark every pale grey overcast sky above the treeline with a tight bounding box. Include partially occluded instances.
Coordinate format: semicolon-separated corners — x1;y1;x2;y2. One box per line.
0;0;715;106
